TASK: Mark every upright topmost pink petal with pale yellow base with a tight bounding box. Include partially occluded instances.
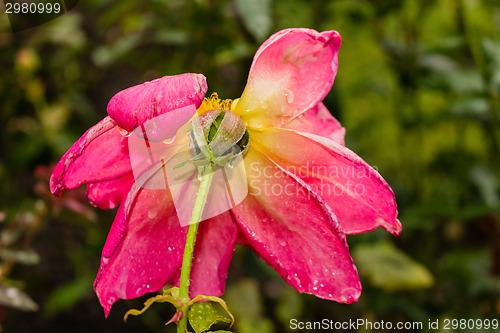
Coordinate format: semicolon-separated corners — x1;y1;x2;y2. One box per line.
234;29;341;128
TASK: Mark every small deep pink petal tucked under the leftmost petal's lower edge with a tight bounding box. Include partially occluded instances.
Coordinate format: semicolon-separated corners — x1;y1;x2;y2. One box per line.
87;173;134;209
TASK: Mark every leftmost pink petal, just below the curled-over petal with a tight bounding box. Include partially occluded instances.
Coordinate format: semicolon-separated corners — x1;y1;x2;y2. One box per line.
50;117;131;196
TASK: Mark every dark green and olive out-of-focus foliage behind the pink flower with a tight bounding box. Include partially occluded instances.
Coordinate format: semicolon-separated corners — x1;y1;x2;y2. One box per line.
0;0;500;333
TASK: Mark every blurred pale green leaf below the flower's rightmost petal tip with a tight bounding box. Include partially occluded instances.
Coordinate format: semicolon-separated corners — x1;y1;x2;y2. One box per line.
353;242;434;291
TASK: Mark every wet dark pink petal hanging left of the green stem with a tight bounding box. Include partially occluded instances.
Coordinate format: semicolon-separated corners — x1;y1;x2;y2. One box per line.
94;185;187;316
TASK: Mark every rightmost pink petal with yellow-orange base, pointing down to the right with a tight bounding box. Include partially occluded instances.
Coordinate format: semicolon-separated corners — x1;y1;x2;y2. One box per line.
252;128;401;235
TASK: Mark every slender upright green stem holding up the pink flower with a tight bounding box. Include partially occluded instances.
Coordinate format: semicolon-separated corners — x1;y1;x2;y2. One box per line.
177;170;214;333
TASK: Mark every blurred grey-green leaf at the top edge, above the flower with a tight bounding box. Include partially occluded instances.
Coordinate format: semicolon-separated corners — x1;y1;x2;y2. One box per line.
235;0;272;41
